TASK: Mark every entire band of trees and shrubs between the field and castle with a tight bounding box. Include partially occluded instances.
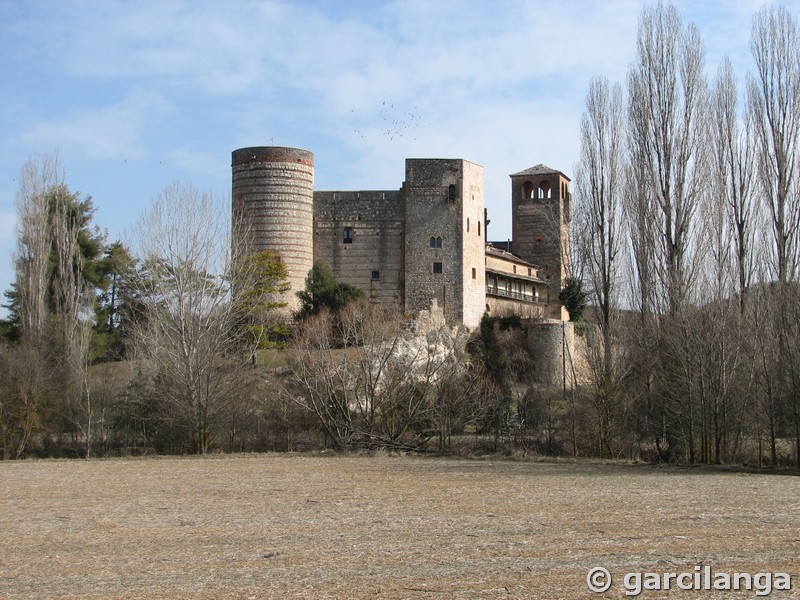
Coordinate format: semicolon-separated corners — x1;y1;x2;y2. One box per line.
0;4;800;466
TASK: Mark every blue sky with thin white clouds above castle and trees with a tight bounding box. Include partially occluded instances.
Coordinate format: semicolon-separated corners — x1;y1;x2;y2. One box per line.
0;0;800;312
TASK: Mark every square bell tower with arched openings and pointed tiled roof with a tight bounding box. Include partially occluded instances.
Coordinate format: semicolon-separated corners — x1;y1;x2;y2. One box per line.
511;164;572;320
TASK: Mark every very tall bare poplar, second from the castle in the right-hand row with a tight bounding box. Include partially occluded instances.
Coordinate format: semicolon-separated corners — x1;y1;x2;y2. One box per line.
627;3;707;461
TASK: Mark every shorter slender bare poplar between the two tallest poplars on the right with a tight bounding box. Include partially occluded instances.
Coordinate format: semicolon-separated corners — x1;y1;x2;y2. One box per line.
683;59;757;463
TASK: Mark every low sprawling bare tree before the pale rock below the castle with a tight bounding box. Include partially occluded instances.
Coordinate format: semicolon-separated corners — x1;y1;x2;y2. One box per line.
286;302;469;450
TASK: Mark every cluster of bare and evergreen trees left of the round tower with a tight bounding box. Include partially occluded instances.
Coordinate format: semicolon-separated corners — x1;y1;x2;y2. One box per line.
0;166;296;458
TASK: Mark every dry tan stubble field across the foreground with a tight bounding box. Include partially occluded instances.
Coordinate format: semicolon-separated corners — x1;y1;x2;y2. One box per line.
0;455;800;599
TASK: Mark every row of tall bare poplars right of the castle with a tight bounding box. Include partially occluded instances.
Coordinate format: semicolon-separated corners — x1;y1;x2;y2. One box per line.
572;4;800;466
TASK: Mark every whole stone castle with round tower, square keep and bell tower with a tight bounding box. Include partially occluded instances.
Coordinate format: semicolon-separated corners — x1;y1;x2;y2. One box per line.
232;146;571;328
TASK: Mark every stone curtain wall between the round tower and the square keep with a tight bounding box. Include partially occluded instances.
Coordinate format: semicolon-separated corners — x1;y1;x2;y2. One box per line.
314;190;405;303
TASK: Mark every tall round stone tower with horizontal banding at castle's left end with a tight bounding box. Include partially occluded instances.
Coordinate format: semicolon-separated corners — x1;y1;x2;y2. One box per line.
232;146;314;310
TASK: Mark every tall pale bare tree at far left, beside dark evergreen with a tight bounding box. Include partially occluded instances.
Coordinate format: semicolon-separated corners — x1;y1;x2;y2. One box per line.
9;156;103;456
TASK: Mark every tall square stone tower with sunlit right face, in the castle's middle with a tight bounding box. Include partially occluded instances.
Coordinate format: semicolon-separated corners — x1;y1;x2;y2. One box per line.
403;158;486;327
